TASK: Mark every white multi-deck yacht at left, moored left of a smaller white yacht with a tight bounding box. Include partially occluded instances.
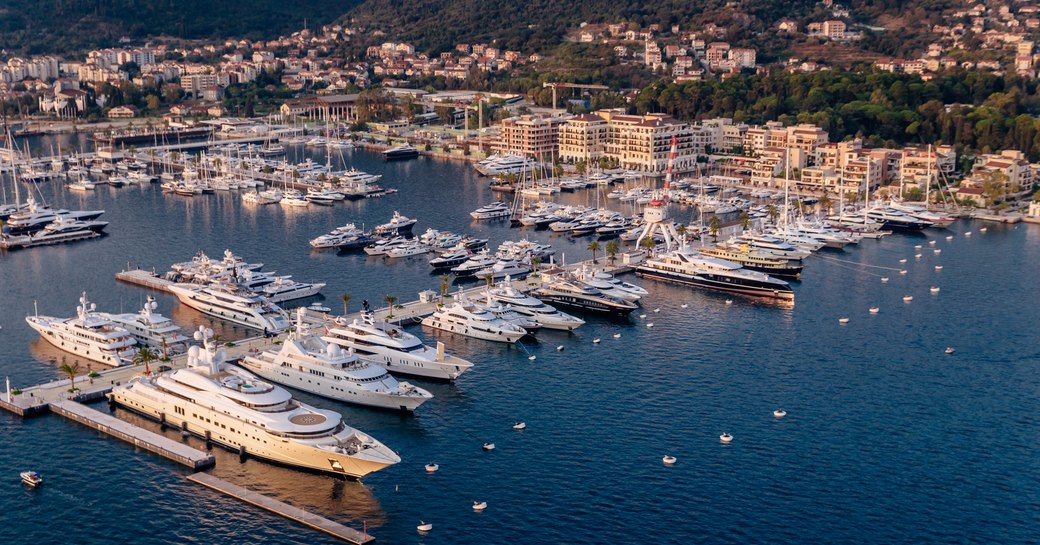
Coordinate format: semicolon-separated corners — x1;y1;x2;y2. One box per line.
25;292;137;367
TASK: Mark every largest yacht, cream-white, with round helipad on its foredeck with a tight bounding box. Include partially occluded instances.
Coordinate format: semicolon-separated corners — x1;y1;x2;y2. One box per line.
109;329;400;478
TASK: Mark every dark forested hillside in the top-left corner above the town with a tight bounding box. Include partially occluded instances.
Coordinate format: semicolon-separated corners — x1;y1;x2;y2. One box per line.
0;0;358;54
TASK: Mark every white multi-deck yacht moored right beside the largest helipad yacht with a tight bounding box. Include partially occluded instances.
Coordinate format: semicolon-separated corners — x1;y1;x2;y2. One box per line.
238;309;433;412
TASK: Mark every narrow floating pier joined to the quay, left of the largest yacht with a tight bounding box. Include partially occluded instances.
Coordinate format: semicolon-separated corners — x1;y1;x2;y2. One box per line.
50;399;215;471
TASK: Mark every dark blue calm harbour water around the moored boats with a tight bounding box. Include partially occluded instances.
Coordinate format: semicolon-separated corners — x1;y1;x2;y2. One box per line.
0;145;1040;544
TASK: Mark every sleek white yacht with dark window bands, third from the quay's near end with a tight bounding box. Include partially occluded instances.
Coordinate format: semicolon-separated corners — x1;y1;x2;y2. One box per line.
321;312;473;381
